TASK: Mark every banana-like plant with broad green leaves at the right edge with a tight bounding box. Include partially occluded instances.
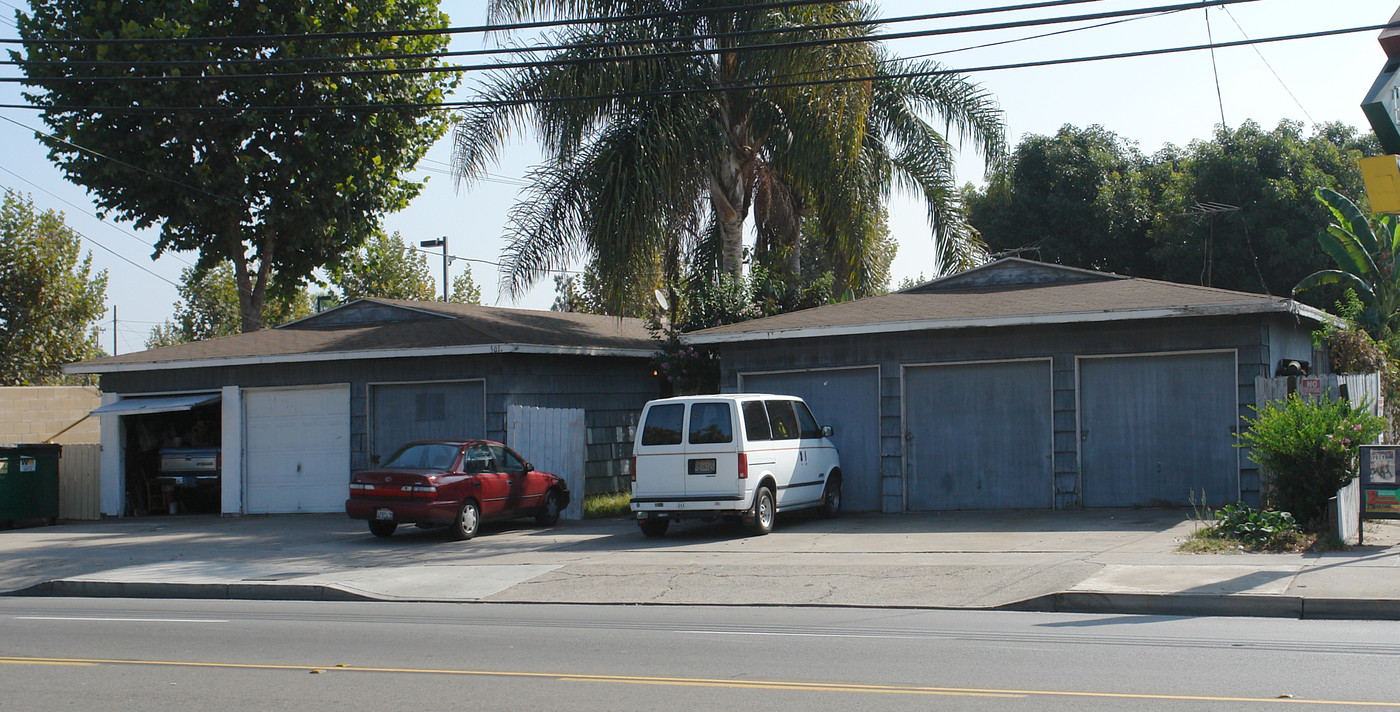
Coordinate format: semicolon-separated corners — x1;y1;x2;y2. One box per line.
1294;187;1400;341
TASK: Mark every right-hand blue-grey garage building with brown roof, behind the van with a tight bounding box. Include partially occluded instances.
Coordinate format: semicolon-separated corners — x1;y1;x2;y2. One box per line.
686;259;1329;512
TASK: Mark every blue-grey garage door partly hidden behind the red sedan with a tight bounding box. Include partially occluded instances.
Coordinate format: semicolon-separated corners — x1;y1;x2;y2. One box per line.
370;380;486;463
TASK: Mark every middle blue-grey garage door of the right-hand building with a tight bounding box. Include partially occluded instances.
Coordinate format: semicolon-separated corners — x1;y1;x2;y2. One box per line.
904;359;1054;511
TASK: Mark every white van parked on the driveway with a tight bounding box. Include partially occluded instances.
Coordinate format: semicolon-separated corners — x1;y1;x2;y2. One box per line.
631;393;841;537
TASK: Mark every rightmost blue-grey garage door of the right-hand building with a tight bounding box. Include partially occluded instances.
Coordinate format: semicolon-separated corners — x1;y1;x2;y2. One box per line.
1079;353;1239;506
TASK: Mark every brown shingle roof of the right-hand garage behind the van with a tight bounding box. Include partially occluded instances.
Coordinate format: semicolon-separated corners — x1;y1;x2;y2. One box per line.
686;260;1326;343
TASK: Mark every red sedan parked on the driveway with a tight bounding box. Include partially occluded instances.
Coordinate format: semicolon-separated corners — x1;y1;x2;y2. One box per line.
346;441;568;540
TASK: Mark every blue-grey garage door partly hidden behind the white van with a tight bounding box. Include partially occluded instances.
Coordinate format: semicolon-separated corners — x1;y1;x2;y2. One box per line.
742;368;881;512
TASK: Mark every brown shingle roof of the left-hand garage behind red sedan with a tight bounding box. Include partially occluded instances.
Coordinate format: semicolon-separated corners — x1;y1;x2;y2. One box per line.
64;299;657;373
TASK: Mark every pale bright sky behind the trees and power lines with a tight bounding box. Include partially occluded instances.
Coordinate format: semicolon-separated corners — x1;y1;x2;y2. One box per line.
0;0;1396;354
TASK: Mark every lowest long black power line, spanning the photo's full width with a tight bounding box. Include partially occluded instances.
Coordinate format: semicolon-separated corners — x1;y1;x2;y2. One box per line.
0;22;1400;118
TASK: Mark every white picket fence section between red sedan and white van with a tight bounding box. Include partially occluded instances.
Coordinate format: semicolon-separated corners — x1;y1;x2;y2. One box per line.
505;406;588;519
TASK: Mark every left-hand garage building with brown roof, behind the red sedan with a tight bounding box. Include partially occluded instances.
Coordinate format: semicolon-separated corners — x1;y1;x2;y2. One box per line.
67;299;661;515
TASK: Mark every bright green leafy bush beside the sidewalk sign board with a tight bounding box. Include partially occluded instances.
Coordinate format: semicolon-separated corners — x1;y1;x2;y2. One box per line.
1239;394;1385;532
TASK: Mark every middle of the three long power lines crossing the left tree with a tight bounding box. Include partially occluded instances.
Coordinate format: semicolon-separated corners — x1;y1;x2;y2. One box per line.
0;0;1257;85
